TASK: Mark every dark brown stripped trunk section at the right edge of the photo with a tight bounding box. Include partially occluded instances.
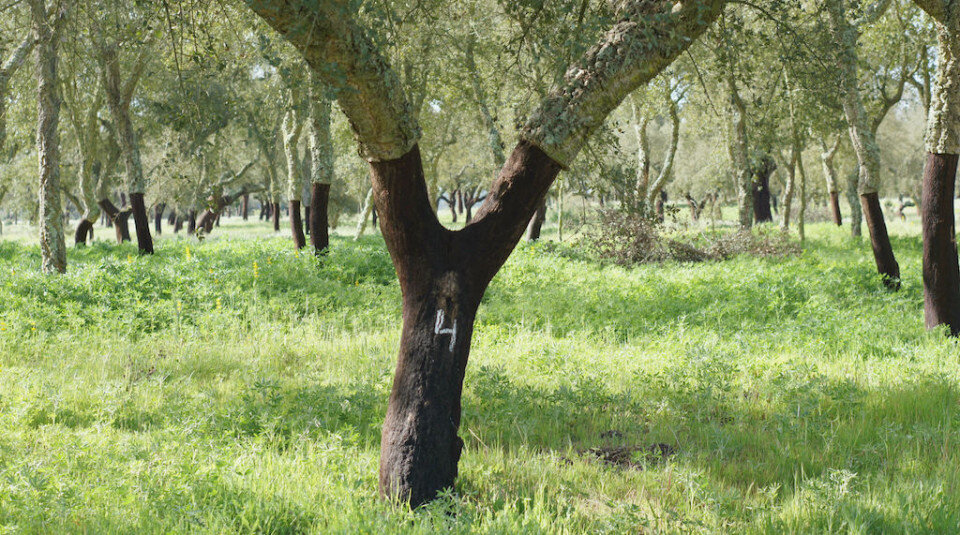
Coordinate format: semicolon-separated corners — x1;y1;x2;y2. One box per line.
920;154;960;336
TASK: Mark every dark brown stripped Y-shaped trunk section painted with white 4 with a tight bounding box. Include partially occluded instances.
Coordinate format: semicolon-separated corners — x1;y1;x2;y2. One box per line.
370;142;560;506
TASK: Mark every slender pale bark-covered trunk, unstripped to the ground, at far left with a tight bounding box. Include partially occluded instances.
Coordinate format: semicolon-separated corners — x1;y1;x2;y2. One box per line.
30;0;67;273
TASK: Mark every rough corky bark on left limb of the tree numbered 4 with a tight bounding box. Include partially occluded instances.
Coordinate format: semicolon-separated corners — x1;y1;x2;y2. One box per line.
244;0;420;162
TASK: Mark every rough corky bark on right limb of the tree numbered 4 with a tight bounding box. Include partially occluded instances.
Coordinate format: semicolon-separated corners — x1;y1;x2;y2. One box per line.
520;0;726;167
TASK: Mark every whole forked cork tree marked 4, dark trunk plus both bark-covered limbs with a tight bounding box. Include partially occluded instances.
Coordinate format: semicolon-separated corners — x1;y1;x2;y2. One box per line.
247;0;725;506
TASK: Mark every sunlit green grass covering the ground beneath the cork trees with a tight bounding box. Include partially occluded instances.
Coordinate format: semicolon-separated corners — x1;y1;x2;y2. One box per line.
0;216;960;534
